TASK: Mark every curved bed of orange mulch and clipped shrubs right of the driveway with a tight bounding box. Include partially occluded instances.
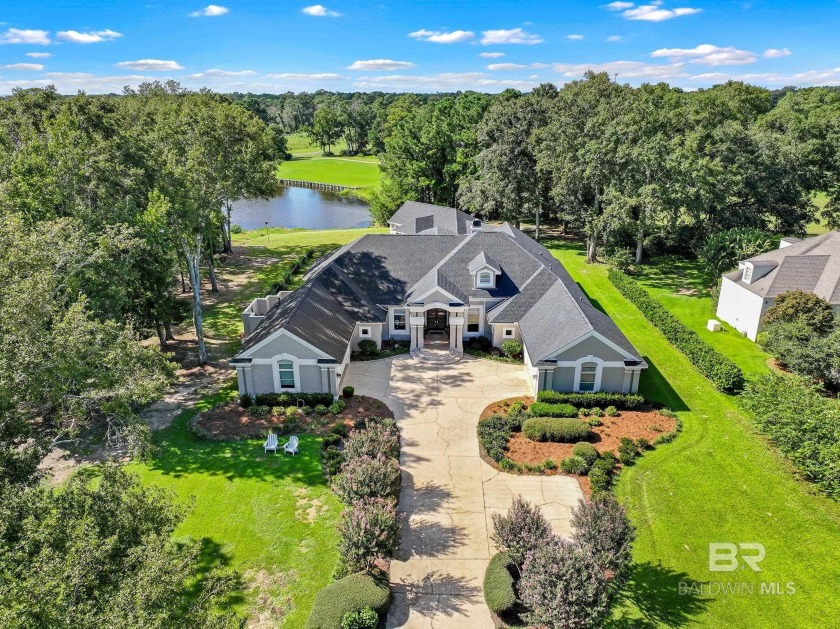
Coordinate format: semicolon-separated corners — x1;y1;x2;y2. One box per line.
478;396;679;495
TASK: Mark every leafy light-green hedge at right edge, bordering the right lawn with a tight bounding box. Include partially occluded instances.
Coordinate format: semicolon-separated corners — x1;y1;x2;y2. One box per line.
743;374;840;499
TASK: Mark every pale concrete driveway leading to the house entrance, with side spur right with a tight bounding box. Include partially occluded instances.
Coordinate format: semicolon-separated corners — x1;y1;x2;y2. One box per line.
342;356;582;629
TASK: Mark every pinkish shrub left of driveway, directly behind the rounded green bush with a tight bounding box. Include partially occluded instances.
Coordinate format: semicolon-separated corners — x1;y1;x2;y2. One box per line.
338;498;400;574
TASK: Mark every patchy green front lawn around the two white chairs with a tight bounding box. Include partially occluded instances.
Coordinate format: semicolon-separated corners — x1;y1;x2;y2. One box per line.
127;388;341;628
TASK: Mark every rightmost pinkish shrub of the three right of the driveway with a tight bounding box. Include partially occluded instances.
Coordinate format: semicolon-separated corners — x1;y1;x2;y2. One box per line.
571;494;636;581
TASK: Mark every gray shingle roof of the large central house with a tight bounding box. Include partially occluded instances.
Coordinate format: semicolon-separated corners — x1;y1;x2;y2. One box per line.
236;202;640;362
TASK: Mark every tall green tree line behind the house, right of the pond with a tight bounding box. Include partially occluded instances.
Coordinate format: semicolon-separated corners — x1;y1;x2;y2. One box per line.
373;73;840;261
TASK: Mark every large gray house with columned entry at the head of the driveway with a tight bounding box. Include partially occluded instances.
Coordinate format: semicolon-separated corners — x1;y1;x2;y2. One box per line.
231;202;647;394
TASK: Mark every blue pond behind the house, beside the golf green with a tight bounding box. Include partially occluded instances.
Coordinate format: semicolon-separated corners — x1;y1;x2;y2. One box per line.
231;186;371;229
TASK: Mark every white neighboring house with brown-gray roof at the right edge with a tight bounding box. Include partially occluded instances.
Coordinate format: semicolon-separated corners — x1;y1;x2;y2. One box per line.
717;231;840;341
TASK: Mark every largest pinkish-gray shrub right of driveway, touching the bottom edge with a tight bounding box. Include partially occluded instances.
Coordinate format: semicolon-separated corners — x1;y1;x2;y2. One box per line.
519;537;610;627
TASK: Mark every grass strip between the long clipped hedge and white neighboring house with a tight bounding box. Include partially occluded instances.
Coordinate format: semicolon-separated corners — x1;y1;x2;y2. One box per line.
634;258;770;380
